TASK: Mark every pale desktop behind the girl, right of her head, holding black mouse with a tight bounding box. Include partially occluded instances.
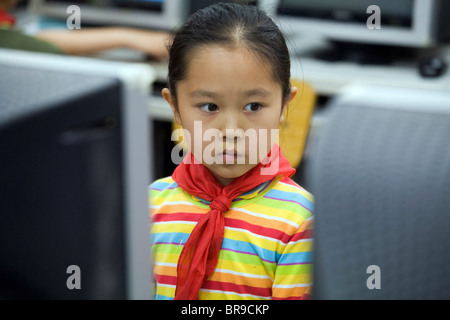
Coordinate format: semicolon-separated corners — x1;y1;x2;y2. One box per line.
288;37;450;96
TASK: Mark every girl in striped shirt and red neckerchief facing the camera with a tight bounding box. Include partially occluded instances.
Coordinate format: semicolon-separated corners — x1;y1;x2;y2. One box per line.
149;3;313;300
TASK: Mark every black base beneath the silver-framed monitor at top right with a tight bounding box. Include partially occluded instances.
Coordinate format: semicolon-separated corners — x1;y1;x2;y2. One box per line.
312;41;416;65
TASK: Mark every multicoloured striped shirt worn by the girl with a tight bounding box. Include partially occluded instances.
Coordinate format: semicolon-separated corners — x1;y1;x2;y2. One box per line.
149;177;314;300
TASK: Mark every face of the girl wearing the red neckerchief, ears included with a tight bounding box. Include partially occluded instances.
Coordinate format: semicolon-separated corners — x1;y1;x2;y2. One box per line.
162;45;297;185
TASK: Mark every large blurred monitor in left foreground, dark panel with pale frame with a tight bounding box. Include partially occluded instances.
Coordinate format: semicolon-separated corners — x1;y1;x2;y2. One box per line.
0;49;154;300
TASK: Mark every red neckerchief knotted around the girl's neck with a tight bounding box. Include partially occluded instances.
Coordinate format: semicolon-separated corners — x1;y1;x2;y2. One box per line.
172;144;295;300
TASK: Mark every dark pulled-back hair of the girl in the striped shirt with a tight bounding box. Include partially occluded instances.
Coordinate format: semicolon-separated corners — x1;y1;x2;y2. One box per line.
168;2;291;105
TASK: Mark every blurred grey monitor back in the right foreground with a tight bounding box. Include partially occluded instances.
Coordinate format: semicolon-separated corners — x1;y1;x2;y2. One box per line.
307;86;450;300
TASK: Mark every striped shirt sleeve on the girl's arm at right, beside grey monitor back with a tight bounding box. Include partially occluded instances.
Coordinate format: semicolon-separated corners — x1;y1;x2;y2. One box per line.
272;215;313;300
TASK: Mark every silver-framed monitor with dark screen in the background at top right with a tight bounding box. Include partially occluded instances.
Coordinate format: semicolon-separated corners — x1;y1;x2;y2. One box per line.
260;0;450;52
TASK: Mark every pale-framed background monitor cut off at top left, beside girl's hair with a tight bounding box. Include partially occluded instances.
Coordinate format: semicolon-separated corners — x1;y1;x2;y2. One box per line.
33;0;189;30
